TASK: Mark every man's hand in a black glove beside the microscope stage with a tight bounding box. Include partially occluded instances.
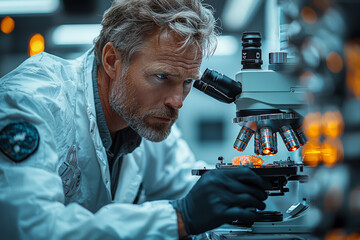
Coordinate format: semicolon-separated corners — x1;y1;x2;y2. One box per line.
172;167;267;235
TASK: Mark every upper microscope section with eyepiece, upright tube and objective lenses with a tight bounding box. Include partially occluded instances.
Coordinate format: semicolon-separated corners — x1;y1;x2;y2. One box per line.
194;32;307;156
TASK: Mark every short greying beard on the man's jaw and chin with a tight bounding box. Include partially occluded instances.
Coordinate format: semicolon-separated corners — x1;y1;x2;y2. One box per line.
109;76;179;142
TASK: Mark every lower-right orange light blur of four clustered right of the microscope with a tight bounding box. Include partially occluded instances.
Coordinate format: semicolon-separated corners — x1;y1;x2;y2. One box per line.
321;138;344;167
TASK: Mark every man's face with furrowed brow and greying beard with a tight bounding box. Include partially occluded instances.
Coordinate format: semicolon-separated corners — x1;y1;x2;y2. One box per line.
109;30;202;142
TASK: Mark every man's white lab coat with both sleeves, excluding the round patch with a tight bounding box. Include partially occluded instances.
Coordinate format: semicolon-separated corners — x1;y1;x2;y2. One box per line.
0;50;203;240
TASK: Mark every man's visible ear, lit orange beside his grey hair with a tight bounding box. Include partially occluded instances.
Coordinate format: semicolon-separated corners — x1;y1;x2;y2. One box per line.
102;42;122;79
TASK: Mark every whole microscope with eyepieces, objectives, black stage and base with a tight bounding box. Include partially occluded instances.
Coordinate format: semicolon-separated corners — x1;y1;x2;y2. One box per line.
192;32;309;239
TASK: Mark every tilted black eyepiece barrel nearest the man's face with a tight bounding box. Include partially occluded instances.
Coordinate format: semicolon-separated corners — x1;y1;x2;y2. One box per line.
201;68;242;98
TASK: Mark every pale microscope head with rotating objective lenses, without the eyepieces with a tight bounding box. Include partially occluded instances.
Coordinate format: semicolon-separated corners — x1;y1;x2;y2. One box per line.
233;68;307;156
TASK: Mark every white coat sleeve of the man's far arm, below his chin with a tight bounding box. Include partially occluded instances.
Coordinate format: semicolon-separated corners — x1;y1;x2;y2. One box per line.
143;125;208;201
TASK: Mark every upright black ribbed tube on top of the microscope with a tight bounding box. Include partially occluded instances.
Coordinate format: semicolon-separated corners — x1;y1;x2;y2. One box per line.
241;32;263;69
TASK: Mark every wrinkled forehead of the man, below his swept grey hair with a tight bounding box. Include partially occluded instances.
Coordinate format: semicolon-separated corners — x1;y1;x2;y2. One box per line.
133;31;202;78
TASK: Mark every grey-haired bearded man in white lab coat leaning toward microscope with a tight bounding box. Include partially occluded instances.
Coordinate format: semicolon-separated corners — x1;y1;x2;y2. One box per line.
0;0;266;239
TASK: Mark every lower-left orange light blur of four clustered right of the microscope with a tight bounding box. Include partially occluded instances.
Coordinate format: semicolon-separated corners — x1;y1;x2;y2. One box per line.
302;139;321;167
